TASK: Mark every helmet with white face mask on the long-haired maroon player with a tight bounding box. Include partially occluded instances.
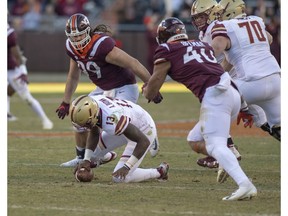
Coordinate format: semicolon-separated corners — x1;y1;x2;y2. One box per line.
65;13;91;50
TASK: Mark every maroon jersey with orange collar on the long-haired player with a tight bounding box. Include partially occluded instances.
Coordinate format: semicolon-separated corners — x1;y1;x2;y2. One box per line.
66;33;136;90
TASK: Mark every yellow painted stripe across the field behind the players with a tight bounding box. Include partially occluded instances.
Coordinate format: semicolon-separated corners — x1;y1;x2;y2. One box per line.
29;82;190;93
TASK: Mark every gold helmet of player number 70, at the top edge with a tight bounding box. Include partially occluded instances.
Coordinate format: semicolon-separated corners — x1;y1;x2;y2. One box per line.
219;0;246;20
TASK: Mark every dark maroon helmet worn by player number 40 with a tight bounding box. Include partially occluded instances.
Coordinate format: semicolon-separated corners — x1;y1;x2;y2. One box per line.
156;17;188;44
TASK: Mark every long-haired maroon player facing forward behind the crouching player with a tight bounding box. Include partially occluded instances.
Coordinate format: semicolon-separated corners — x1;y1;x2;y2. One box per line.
56;13;162;167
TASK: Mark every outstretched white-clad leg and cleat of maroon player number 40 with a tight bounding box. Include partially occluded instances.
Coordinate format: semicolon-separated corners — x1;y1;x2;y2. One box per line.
200;87;257;200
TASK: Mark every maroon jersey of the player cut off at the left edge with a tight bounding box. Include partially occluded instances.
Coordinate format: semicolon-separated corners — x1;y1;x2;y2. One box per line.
7;26;17;70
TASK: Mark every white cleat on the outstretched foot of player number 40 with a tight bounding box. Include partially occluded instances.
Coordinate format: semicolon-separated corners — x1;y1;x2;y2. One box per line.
222;184;257;201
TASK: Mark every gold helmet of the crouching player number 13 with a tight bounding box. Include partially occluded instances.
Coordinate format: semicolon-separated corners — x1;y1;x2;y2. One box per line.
70;95;99;128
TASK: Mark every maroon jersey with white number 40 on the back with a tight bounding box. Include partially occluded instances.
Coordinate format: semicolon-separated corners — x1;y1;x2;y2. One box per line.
154;40;224;102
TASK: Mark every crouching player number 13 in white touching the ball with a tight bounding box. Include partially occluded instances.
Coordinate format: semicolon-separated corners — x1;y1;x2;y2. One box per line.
70;95;169;183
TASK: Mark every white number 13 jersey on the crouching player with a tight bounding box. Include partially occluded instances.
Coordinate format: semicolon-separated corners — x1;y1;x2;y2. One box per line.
90;95;155;135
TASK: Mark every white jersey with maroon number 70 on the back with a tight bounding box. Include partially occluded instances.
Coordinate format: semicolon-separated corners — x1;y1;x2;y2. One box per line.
211;16;280;81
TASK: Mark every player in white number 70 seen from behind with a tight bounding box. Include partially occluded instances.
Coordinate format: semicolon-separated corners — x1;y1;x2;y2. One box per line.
211;0;281;141
